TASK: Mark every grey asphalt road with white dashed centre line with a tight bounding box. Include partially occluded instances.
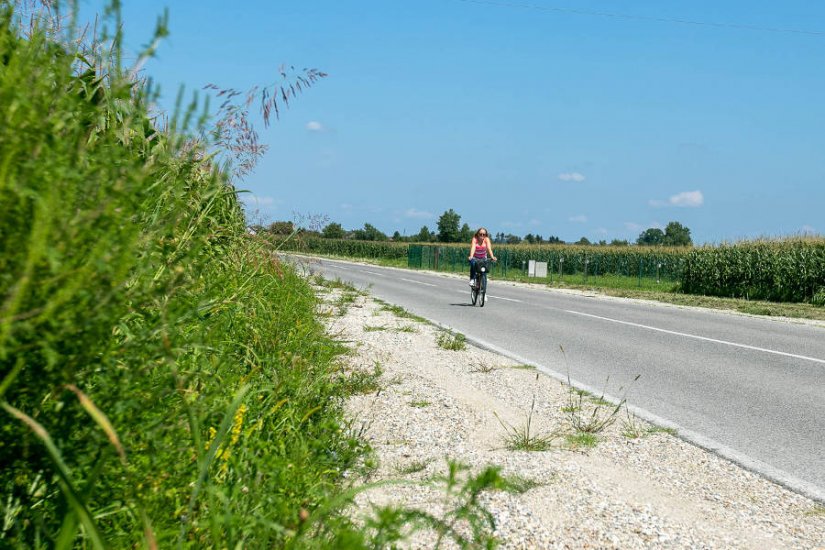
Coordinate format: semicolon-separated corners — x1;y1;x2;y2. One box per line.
303;259;825;502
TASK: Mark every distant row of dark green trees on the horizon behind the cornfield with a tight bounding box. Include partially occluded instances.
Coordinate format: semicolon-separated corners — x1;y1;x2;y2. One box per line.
251;208;693;246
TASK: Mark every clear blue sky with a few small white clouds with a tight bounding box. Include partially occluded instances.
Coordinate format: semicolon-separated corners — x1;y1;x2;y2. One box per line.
82;0;825;243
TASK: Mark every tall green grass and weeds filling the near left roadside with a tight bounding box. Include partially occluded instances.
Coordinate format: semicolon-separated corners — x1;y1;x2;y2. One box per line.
0;3;360;548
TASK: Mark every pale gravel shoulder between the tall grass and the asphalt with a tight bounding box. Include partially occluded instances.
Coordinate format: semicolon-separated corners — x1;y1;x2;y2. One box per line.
320;290;825;549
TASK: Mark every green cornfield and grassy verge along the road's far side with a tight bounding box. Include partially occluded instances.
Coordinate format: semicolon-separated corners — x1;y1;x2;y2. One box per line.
276;238;825;320
